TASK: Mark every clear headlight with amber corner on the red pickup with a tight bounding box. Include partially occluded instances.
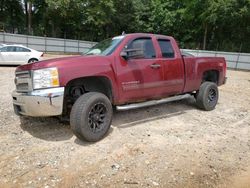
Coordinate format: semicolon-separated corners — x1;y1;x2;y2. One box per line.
33;68;59;89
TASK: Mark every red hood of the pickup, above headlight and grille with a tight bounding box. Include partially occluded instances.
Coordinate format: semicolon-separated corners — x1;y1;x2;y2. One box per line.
16;56;110;71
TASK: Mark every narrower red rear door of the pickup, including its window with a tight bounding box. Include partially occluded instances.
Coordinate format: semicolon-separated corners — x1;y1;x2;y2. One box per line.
157;39;185;95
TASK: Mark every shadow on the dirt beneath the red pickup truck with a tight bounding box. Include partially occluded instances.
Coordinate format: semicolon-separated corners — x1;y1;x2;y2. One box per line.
20;97;196;142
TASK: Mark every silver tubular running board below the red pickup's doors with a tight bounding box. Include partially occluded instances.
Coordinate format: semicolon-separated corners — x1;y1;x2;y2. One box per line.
116;94;191;111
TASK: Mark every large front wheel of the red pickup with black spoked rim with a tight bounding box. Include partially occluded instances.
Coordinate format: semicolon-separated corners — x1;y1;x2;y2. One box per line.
70;92;113;142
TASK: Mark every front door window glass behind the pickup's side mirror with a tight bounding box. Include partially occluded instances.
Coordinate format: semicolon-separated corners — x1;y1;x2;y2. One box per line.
127;38;156;59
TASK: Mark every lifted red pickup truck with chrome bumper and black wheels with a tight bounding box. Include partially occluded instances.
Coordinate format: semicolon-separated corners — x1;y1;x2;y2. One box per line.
12;33;226;141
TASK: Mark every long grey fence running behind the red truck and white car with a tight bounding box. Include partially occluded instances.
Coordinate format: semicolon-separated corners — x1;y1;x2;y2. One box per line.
0;32;250;70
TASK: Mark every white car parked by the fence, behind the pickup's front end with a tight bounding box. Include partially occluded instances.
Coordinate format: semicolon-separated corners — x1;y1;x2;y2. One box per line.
0;45;43;65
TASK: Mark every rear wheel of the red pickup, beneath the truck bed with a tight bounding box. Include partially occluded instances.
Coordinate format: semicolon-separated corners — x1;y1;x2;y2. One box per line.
196;82;219;111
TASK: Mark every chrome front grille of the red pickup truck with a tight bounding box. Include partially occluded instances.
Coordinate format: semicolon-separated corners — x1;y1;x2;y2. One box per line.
15;71;32;92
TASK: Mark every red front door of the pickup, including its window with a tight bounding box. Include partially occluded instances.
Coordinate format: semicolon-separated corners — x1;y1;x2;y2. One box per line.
117;37;163;102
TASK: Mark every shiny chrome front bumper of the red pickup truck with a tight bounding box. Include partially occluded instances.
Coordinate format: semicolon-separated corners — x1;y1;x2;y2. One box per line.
12;87;64;117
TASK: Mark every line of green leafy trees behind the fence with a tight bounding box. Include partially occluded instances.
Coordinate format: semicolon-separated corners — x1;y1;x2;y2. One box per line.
0;0;250;52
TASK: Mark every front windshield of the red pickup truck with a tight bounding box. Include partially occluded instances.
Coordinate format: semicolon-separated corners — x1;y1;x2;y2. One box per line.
84;36;124;56
